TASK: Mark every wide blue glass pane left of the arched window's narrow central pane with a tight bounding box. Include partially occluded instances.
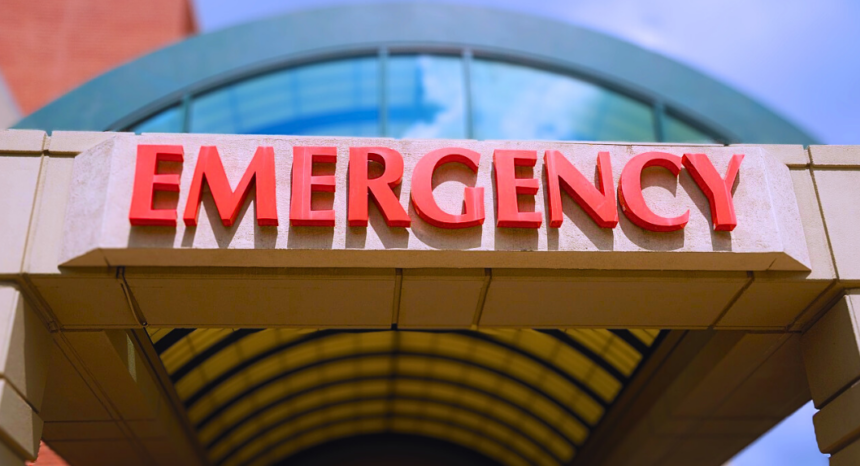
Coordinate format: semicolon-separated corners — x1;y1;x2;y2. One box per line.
191;57;379;136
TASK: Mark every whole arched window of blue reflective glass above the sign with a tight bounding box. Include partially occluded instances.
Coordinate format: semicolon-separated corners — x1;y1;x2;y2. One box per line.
128;54;715;143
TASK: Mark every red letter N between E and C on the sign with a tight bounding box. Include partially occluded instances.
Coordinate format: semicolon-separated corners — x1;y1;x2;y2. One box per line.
544;150;618;228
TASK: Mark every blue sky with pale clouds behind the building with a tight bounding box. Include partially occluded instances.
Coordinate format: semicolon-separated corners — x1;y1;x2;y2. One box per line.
195;0;844;460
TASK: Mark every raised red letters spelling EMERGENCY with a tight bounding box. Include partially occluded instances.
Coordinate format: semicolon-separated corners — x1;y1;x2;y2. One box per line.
129;144;744;232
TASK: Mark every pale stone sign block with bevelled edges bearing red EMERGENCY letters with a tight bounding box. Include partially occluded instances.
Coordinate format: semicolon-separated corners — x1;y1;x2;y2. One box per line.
61;134;809;271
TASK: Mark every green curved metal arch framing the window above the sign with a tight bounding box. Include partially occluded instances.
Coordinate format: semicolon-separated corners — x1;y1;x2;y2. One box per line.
15;3;816;144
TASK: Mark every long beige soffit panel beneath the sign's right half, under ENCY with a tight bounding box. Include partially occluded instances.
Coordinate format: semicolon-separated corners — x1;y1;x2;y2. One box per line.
480;270;748;328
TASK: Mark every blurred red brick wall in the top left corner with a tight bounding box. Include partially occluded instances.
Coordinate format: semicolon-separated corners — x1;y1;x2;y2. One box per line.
0;0;195;115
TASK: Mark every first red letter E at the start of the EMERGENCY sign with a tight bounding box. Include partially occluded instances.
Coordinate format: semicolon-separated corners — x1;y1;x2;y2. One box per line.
128;144;184;227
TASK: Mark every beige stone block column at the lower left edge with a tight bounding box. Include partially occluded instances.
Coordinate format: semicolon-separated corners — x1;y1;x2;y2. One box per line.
0;282;53;465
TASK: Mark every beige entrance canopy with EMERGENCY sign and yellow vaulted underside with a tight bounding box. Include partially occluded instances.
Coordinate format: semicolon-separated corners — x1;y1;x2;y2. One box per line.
0;131;856;466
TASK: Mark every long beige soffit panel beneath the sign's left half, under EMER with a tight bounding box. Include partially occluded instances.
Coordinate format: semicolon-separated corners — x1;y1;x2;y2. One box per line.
126;269;395;327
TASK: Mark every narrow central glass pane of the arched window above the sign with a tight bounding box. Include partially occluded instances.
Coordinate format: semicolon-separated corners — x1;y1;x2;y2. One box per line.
386;55;466;139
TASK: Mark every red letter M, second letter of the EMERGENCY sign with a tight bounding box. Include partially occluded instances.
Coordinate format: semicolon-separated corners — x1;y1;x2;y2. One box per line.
183;146;278;227
